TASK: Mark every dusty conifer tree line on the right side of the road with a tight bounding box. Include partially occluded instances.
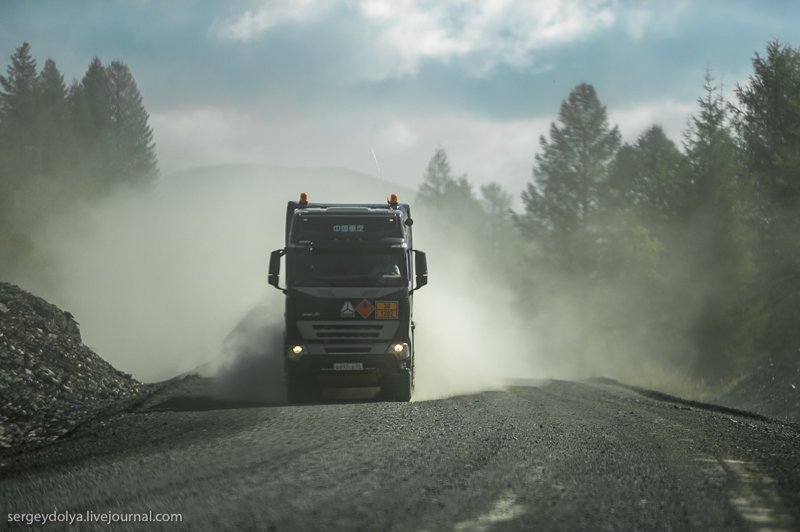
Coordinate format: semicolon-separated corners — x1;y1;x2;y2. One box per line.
418;41;800;383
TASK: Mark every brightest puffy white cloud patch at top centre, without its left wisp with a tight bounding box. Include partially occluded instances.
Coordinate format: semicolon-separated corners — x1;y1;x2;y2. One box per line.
360;0;615;73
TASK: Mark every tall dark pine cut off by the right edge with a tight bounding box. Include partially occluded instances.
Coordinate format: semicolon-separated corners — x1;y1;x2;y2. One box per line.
735;41;800;352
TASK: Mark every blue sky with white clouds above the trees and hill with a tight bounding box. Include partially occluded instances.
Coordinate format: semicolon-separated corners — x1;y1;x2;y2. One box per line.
0;0;800;200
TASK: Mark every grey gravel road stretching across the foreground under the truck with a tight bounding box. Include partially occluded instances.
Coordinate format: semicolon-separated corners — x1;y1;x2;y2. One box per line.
0;381;800;531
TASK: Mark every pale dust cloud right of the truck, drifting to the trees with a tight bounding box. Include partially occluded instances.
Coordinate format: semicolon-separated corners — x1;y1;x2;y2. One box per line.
414;206;709;400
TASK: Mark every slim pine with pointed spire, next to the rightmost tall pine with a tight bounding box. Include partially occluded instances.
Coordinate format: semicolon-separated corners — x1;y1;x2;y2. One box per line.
681;74;758;378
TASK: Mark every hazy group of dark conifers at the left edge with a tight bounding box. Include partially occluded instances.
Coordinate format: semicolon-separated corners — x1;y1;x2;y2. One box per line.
0;43;159;272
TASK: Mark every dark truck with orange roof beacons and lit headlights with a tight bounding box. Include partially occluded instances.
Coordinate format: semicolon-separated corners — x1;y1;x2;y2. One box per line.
268;193;428;403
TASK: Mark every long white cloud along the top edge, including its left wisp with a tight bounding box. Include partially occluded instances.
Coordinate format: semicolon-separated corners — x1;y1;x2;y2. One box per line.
211;0;667;78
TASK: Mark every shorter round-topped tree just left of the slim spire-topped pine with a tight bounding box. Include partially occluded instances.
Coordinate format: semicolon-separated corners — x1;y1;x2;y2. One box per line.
603;125;691;338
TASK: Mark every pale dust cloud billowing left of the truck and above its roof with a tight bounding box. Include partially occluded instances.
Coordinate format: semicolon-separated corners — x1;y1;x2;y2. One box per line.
11;165;412;386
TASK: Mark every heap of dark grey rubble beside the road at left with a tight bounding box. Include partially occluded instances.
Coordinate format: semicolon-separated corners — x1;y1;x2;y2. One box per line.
0;282;149;454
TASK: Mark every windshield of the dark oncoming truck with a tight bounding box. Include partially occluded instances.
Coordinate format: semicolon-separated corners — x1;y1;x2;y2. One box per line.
293;249;408;286
